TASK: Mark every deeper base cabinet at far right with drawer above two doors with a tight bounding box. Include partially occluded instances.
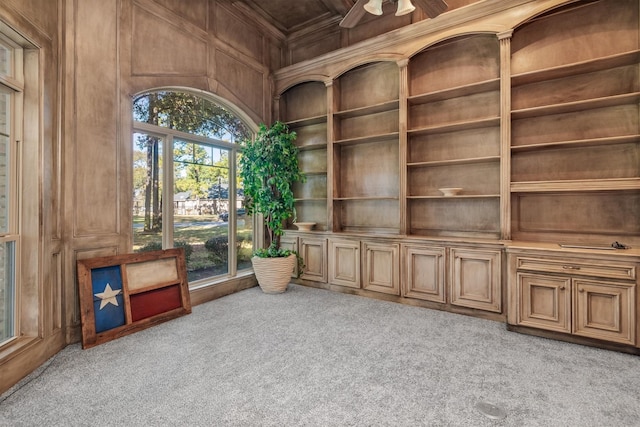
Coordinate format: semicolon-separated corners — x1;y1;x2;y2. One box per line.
509;253;637;345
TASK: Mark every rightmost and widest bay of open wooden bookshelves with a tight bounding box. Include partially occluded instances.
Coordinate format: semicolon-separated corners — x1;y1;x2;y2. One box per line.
510;0;640;245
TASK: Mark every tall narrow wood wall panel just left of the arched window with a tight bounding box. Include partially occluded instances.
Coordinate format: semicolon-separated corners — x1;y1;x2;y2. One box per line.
75;0;120;236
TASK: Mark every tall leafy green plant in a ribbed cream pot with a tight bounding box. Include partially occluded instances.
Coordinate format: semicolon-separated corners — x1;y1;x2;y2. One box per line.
240;121;306;293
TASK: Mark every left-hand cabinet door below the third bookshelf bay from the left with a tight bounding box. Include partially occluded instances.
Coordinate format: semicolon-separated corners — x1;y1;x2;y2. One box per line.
402;246;446;303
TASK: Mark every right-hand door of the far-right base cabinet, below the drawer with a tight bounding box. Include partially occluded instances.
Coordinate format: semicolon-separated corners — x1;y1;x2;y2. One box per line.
573;279;636;344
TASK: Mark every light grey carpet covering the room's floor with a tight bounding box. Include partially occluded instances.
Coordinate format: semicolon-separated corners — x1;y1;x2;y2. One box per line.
0;285;640;427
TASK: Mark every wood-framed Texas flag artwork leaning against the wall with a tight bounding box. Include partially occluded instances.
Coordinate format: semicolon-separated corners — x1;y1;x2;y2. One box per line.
77;248;191;349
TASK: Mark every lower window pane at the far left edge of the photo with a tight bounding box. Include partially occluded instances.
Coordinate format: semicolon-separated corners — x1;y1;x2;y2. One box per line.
0;242;15;344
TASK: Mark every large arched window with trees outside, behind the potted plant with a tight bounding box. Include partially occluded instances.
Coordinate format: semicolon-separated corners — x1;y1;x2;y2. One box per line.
133;90;255;285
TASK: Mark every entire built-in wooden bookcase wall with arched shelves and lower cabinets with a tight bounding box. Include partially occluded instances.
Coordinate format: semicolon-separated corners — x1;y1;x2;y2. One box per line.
274;0;640;350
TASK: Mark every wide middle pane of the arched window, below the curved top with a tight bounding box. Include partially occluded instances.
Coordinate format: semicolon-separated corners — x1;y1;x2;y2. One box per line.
173;139;229;281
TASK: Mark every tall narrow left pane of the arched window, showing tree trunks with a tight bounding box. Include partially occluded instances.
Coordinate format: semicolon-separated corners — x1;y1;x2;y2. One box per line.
133;133;162;252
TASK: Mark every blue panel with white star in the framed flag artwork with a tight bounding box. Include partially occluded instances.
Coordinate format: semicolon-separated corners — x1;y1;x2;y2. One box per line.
91;265;125;333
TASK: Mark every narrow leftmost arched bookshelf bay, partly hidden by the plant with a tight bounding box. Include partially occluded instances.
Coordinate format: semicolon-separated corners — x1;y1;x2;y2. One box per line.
279;82;328;231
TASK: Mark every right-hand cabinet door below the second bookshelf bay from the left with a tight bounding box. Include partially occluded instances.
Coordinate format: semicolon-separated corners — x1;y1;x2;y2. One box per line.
362;242;400;295
